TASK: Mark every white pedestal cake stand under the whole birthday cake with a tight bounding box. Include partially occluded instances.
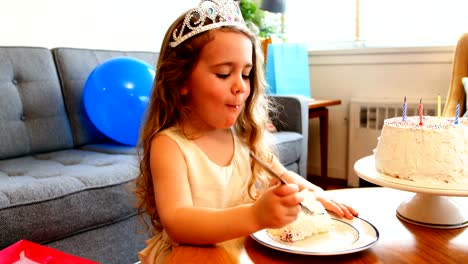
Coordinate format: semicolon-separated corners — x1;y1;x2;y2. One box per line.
354;155;468;229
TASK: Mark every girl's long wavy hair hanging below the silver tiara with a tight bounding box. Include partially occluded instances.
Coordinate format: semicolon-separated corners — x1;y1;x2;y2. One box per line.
135;10;275;231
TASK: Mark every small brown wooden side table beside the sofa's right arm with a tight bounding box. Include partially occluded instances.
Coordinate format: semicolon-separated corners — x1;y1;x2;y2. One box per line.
308;99;341;190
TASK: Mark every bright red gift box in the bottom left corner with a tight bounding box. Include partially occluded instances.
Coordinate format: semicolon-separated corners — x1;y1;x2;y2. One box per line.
0;240;98;264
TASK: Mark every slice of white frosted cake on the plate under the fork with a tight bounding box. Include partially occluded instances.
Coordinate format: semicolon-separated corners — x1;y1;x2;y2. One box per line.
267;191;333;242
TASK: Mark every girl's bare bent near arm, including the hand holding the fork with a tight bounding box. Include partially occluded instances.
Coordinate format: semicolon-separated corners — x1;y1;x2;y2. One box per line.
150;136;303;245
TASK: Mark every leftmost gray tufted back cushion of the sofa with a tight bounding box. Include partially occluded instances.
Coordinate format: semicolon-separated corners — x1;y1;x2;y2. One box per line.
0;47;73;159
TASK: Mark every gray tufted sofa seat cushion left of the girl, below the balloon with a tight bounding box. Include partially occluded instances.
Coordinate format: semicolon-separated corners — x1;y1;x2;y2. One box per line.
0;149;138;248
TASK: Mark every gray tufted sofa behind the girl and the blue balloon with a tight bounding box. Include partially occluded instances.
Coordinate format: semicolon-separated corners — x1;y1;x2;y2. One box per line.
0;47;308;263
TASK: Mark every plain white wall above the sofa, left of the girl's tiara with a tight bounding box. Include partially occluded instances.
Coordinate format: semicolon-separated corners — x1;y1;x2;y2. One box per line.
0;0;198;51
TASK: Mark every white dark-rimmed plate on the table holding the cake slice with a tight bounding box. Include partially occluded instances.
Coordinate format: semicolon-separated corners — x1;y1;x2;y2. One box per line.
251;216;379;256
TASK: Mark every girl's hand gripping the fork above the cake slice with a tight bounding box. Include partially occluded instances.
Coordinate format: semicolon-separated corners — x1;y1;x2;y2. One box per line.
252;184;304;229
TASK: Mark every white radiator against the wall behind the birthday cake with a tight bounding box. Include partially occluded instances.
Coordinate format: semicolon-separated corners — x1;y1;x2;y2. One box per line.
347;98;443;187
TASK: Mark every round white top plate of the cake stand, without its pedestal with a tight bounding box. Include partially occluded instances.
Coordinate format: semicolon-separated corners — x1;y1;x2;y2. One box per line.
354;155;468;196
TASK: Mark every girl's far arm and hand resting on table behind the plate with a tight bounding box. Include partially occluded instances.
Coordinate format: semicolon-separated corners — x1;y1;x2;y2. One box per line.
271;158;358;219
